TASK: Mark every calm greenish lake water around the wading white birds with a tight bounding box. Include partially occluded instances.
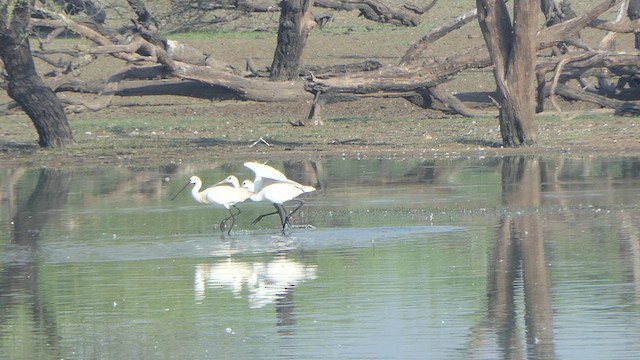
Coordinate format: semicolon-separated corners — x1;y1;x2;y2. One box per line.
0;156;640;359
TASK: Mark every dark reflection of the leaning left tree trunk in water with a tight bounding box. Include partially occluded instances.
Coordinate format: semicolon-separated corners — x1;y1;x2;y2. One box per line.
0;169;73;358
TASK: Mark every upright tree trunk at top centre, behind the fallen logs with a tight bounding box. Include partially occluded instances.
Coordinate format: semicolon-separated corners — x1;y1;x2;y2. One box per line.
271;0;315;81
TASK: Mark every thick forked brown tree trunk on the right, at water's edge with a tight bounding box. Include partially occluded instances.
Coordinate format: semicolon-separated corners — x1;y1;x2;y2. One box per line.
476;0;538;147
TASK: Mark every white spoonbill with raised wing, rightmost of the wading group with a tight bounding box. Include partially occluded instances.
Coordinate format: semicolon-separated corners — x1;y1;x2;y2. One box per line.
242;162;316;233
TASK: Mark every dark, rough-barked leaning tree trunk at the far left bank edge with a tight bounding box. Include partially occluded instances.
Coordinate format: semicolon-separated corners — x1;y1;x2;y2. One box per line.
0;1;73;147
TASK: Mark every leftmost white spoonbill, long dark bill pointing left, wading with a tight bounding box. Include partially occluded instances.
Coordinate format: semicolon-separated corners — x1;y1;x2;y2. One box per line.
171;175;253;235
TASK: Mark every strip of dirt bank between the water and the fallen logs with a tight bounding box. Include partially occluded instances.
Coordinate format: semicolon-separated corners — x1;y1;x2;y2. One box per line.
5;93;640;166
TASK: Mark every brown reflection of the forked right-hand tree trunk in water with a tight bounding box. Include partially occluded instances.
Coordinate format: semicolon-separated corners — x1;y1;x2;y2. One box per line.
488;156;555;359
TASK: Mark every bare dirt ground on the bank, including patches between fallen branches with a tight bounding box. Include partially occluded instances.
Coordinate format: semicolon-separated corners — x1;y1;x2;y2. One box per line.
0;8;640;166
